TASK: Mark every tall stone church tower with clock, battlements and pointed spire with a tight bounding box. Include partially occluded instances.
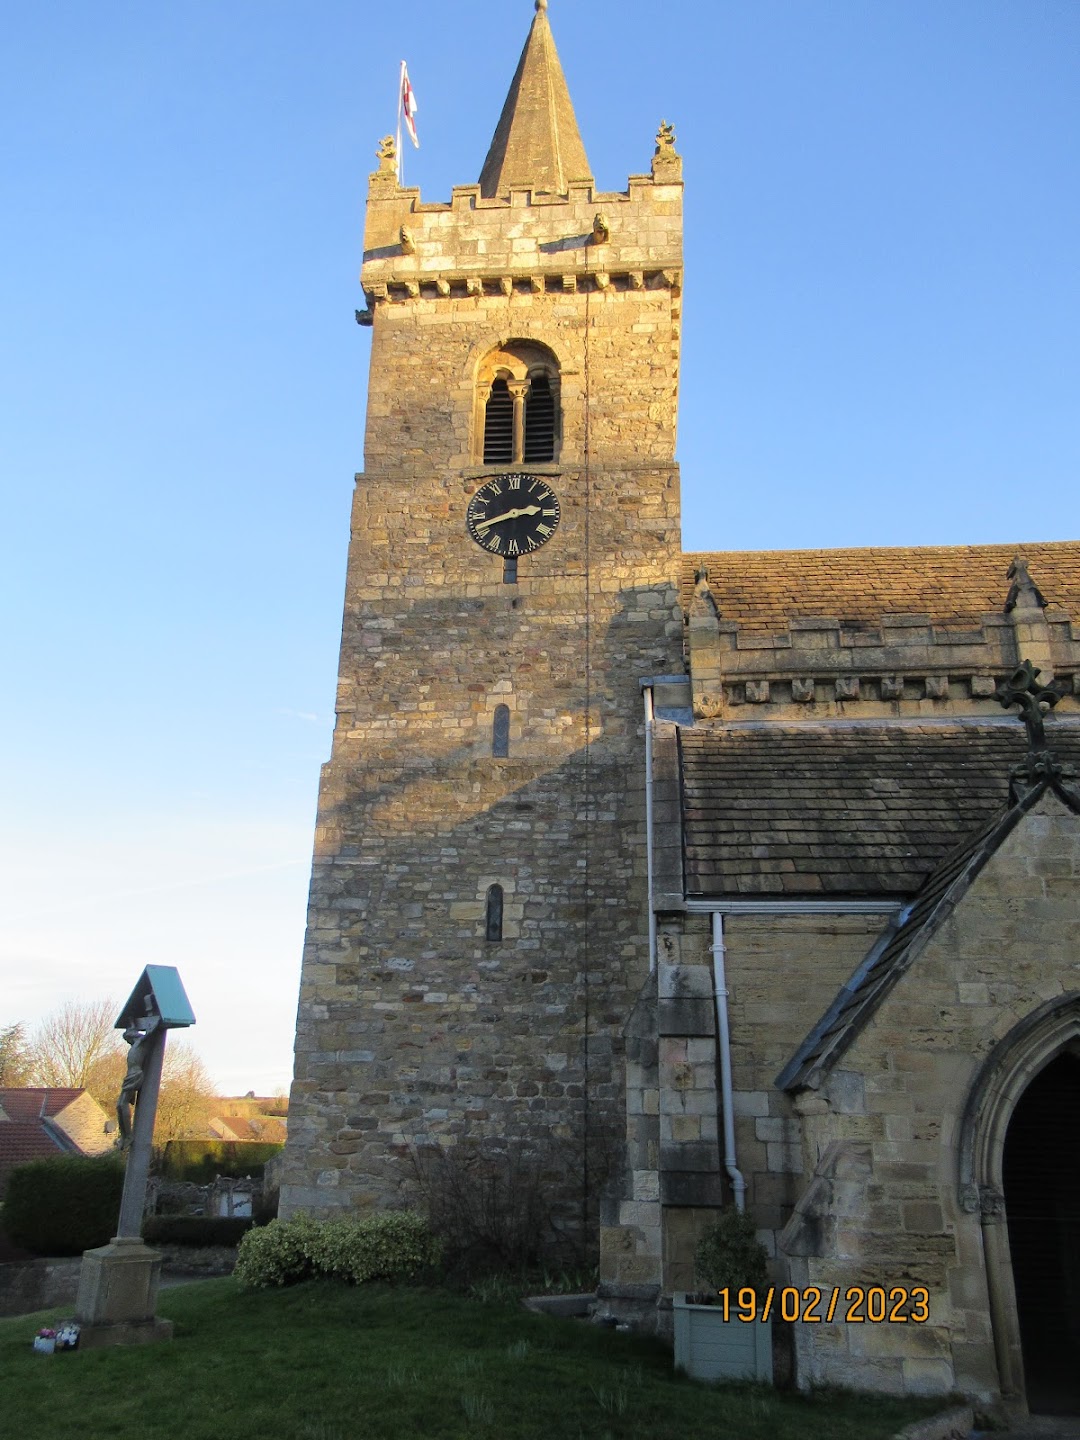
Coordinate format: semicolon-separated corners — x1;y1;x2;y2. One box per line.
282;0;683;1237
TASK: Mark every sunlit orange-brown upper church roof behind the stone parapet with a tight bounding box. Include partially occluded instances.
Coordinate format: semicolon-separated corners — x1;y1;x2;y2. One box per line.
681;540;1080;631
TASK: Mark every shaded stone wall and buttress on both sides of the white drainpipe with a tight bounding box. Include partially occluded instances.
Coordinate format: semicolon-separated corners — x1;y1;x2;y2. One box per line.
600;914;886;1310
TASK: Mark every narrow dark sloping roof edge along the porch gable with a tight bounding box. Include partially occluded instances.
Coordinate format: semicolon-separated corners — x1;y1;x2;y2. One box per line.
776;780;1080;1090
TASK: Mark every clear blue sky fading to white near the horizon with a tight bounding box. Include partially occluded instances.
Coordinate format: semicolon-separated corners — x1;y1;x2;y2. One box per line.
0;0;1080;1090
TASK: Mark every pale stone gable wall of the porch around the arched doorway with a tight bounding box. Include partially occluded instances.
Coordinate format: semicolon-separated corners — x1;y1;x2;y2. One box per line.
785;796;1080;1398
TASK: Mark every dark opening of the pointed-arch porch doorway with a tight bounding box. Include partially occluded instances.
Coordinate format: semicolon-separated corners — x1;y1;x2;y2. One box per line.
1002;1045;1080;1414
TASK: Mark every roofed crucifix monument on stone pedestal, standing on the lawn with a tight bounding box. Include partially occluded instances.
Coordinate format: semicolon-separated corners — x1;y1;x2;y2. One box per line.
76;965;194;1346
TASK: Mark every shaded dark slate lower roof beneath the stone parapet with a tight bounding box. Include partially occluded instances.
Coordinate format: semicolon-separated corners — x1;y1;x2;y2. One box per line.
678;717;1080;899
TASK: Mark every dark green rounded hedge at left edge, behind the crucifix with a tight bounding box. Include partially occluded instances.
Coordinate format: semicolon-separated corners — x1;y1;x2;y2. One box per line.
4;1155;124;1256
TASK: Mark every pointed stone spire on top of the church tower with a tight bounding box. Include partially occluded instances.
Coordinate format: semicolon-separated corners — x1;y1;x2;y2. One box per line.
480;0;592;199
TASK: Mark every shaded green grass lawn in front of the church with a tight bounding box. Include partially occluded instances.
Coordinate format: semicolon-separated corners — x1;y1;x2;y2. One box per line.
0;1279;940;1440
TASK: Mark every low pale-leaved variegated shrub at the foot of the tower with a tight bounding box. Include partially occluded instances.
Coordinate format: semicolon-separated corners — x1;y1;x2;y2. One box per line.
235;1211;441;1289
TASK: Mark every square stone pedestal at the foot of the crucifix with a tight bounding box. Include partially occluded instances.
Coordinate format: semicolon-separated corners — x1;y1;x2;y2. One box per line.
75;1236;173;1348
